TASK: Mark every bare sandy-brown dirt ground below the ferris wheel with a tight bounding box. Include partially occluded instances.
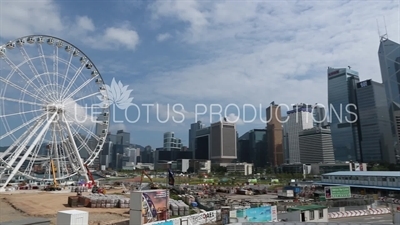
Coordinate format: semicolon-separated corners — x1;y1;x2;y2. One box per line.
0;191;129;225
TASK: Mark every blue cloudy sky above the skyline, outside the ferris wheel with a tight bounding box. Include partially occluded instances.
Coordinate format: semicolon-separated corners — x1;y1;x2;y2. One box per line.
0;0;400;148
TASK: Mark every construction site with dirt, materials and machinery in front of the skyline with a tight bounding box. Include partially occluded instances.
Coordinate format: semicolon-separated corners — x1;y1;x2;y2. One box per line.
0;170;398;225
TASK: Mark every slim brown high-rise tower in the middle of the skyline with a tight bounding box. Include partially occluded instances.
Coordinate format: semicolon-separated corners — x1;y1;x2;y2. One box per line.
266;102;284;167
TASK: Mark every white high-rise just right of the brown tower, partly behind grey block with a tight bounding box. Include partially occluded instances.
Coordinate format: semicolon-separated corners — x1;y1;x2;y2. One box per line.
286;104;314;163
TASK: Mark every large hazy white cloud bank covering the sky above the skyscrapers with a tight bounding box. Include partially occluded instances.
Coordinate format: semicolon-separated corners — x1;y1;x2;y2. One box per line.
138;0;400;110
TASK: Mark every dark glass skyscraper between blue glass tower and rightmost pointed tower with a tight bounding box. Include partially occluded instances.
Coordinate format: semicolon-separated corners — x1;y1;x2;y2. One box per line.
357;80;396;163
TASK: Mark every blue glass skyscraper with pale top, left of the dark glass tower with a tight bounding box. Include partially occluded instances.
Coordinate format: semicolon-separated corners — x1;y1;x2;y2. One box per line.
328;67;361;161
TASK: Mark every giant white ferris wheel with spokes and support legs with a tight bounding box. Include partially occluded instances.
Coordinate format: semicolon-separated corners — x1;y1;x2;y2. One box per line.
0;35;109;190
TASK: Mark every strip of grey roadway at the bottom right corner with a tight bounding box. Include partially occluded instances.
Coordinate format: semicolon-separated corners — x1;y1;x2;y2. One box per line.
329;214;393;225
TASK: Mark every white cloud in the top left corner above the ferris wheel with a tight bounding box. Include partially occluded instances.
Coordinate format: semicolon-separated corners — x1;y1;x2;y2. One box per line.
0;0;139;50
